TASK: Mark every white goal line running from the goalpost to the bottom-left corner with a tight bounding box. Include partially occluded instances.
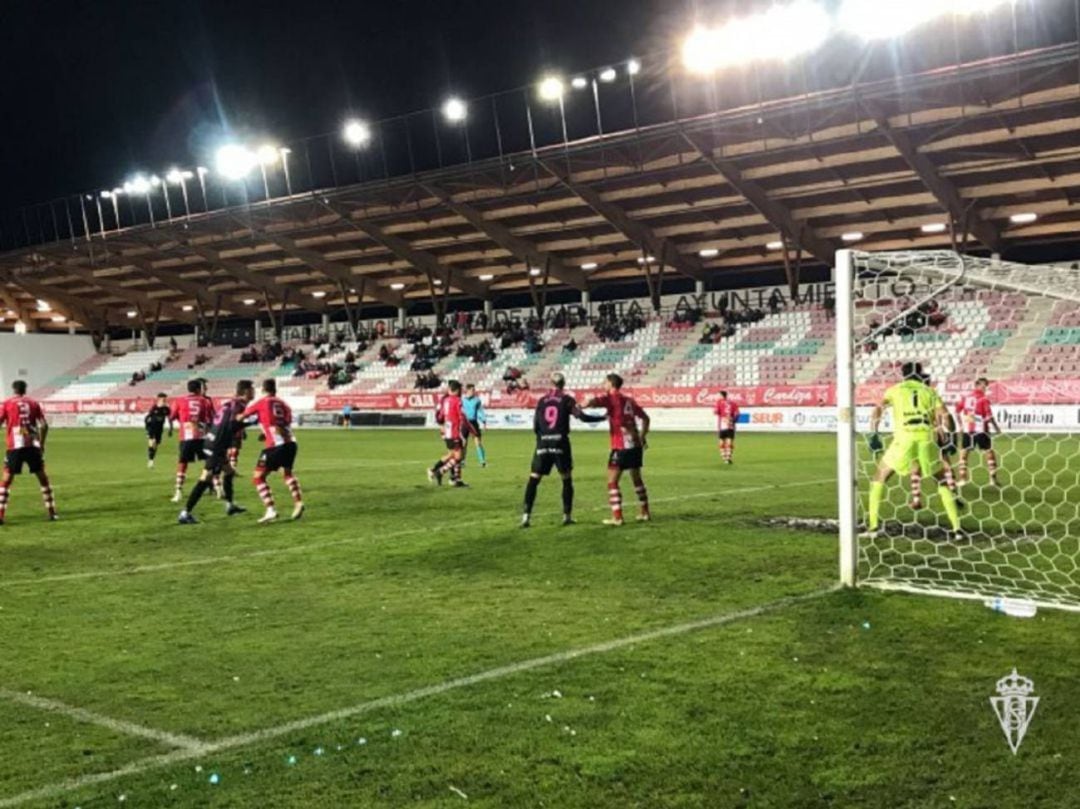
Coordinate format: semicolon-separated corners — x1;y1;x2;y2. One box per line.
0;588;836;809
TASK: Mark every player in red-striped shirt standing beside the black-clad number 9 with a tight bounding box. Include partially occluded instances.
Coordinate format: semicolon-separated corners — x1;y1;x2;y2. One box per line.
585;374;652;525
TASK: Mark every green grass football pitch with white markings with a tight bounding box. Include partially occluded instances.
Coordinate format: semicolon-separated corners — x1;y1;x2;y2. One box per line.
0;430;1080;808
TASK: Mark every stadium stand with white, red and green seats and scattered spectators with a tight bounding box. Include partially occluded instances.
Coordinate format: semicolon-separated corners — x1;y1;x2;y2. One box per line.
23;291;1080;402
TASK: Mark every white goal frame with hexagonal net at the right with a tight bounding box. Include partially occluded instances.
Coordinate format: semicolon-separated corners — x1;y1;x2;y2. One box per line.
836;251;1080;610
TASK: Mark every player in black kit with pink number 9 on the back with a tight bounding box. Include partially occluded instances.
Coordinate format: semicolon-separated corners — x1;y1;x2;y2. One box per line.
522;374;607;528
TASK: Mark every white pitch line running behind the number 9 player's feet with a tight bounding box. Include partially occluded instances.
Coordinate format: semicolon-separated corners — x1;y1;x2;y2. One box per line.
0;477;836;590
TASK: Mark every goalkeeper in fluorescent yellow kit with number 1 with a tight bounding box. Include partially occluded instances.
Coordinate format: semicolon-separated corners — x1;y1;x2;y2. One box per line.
867;362;960;536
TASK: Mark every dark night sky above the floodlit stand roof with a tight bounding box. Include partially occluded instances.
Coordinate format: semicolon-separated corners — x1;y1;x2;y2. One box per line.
0;0;699;211
